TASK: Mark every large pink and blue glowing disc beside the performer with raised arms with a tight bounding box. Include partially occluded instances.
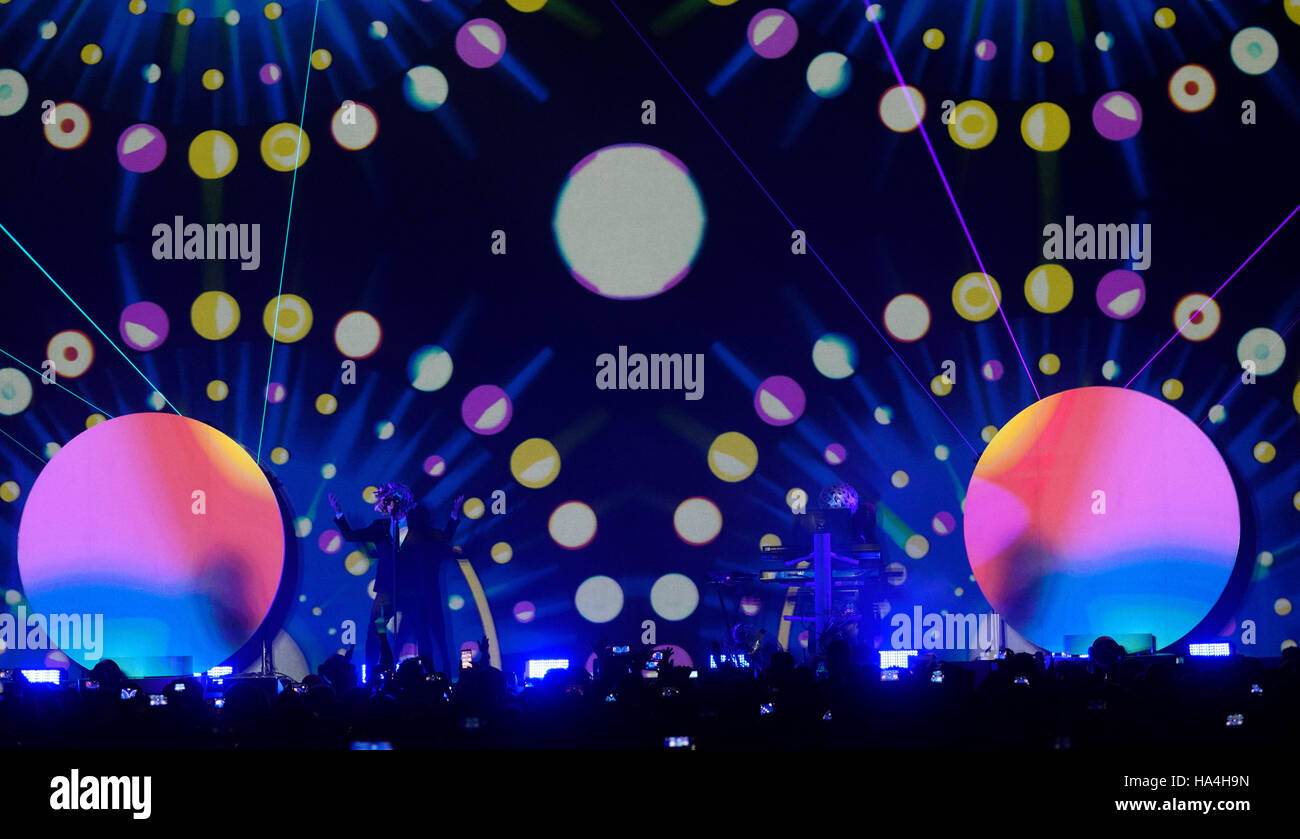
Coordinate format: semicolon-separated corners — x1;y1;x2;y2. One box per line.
18;414;285;670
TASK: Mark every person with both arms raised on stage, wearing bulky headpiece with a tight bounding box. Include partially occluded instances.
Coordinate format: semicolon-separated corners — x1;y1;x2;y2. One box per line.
329;483;465;673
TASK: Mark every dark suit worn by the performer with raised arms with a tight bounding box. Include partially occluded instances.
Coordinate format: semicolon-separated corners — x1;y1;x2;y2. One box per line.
334;506;459;673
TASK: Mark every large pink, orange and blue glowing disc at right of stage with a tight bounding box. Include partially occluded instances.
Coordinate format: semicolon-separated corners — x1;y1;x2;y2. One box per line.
963;388;1242;649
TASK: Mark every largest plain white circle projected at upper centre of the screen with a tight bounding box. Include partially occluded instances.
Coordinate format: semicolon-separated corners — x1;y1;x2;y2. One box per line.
551;143;705;300
